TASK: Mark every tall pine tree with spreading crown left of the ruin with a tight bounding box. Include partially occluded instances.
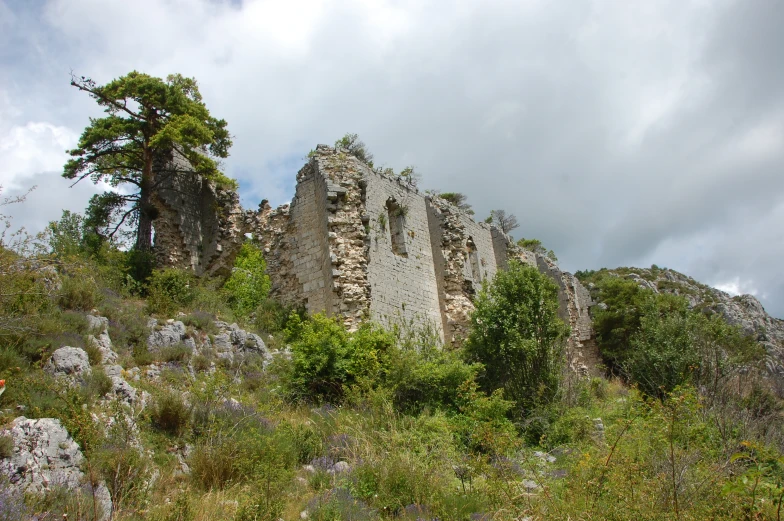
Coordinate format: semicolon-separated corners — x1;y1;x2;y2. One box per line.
63;71;236;251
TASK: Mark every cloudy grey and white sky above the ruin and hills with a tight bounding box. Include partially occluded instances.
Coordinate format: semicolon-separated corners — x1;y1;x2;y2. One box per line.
0;0;784;317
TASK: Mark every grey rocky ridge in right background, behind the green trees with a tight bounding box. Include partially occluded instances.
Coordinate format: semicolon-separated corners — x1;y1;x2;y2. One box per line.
577;266;784;376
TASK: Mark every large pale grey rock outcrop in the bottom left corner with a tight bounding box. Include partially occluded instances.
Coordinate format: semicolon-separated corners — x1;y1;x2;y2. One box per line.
0;416;112;519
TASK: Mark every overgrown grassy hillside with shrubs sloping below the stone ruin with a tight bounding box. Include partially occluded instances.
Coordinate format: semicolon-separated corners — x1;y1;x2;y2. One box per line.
0;213;784;521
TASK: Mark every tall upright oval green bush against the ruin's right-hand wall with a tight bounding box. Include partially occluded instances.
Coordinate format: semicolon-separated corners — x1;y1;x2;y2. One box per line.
466;262;569;414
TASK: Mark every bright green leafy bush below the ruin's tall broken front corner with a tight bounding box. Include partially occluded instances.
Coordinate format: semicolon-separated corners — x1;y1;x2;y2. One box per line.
288;315;395;402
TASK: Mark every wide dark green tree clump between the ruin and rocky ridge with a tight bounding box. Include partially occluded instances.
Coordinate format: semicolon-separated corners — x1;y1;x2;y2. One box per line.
594;277;763;398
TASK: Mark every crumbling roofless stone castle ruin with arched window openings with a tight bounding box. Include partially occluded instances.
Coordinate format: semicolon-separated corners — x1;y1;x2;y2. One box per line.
150;145;591;345
